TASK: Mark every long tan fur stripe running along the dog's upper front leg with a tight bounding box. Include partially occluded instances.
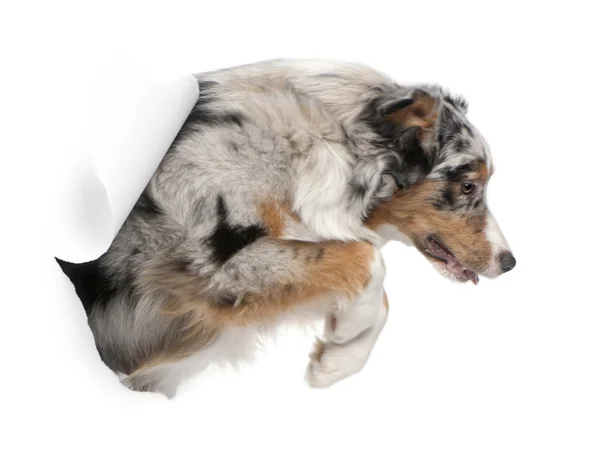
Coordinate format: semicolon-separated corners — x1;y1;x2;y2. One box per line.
144;241;375;332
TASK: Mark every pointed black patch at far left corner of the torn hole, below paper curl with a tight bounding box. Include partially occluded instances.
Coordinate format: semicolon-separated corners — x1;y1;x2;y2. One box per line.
55;258;116;316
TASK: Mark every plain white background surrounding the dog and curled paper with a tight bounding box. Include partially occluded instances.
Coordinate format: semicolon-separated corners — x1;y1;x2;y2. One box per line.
0;0;600;462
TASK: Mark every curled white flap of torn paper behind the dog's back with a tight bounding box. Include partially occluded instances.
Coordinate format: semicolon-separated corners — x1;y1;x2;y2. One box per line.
54;55;198;263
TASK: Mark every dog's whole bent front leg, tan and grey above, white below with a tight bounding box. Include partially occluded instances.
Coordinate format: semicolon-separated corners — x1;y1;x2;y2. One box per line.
202;238;387;387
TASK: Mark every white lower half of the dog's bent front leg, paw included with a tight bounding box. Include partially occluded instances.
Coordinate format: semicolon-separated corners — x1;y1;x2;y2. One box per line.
306;250;388;387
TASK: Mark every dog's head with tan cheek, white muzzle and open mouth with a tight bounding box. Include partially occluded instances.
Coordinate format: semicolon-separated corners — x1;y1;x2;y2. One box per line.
370;85;516;284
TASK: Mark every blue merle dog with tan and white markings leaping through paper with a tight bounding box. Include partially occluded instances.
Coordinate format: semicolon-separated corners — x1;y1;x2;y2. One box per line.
59;60;516;396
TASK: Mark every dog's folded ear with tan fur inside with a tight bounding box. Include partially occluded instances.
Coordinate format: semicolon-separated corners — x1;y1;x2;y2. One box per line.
379;89;440;136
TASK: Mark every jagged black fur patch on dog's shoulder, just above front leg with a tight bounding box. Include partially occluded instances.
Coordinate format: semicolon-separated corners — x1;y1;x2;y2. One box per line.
209;195;266;264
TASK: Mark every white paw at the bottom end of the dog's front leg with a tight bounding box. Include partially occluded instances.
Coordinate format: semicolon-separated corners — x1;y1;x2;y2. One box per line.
306;341;369;388
